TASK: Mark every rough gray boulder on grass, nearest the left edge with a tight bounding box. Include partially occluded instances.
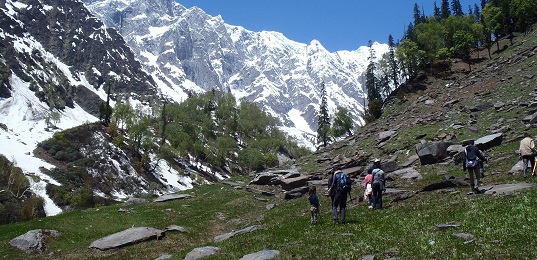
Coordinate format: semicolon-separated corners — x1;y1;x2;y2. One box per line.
9;229;60;253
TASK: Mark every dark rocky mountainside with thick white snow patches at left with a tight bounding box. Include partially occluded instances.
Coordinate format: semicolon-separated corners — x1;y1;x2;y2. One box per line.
0;0;192;215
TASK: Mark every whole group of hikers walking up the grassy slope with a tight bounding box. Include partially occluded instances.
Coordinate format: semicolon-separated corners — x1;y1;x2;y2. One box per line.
308;132;537;224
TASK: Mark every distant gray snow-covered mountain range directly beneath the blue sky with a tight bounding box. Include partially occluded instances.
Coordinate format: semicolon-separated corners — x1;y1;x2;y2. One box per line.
82;0;388;147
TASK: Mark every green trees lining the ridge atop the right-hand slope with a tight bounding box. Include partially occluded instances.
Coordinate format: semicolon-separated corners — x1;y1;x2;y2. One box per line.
364;0;537;122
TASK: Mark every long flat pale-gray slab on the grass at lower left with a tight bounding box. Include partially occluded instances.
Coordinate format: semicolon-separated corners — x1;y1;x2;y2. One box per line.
89;227;164;251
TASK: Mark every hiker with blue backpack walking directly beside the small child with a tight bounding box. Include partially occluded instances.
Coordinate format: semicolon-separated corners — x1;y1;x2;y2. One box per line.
329;168;352;224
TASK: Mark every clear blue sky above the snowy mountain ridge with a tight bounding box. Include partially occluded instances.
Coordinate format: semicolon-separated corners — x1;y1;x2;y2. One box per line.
176;0;480;52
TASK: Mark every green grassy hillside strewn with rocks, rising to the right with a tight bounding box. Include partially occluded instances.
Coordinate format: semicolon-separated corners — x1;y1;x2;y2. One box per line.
0;25;537;259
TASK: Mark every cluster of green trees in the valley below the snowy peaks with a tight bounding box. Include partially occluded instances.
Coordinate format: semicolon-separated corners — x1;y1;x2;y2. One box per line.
101;90;308;173
